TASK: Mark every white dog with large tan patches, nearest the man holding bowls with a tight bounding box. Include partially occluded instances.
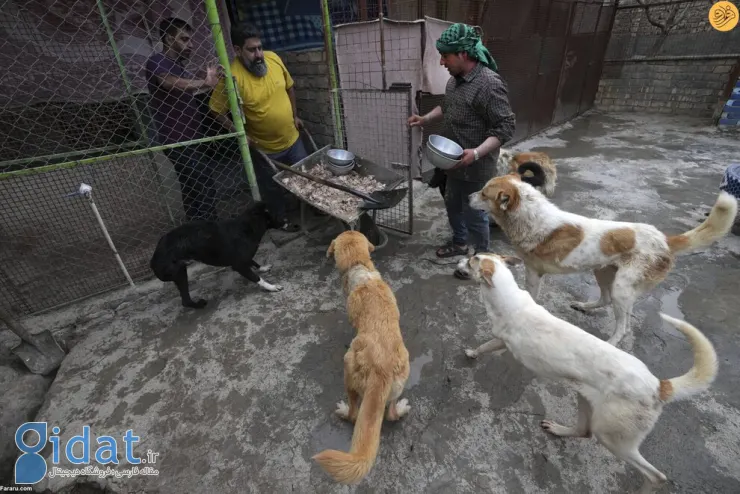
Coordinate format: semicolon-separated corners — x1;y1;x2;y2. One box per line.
466;173;737;345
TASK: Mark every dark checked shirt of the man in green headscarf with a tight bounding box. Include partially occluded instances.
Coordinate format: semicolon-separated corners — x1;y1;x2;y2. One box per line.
442;63;516;182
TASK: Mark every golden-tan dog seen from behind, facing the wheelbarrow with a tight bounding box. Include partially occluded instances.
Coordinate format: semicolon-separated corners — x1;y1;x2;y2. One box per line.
313;231;411;484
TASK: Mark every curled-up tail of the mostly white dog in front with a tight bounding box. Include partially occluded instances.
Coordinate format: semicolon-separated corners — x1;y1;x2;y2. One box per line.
658;312;719;403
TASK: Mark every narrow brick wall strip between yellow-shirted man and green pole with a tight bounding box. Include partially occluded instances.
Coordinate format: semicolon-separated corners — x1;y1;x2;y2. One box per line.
279;49;334;152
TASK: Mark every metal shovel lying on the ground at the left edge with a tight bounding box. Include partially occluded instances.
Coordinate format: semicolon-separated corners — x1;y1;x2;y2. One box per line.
0;307;66;376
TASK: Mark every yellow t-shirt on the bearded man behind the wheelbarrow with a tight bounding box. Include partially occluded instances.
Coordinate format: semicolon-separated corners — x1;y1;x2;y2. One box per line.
209;51;299;153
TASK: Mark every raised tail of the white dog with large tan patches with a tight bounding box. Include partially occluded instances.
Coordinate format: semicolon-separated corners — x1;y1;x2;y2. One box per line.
666;191;737;254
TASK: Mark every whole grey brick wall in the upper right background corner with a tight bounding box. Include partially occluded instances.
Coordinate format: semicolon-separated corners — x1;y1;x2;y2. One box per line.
595;0;740;118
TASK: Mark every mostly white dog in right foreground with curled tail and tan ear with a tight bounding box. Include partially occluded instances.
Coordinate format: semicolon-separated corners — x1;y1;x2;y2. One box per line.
465;254;718;492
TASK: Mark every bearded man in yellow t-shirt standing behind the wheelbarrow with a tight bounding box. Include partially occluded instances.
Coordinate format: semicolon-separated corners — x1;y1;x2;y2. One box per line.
209;24;308;231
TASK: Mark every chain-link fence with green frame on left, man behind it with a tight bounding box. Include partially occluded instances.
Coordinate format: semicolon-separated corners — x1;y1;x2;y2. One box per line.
0;0;254;313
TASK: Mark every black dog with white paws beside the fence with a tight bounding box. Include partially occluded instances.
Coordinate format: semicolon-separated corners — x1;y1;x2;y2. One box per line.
149;202;283;309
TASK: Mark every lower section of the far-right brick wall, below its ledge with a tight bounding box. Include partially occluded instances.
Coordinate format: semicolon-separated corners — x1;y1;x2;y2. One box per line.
595;59;737;118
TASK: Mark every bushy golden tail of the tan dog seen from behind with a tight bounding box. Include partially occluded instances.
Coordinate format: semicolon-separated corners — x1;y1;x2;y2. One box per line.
313;375;391;484
